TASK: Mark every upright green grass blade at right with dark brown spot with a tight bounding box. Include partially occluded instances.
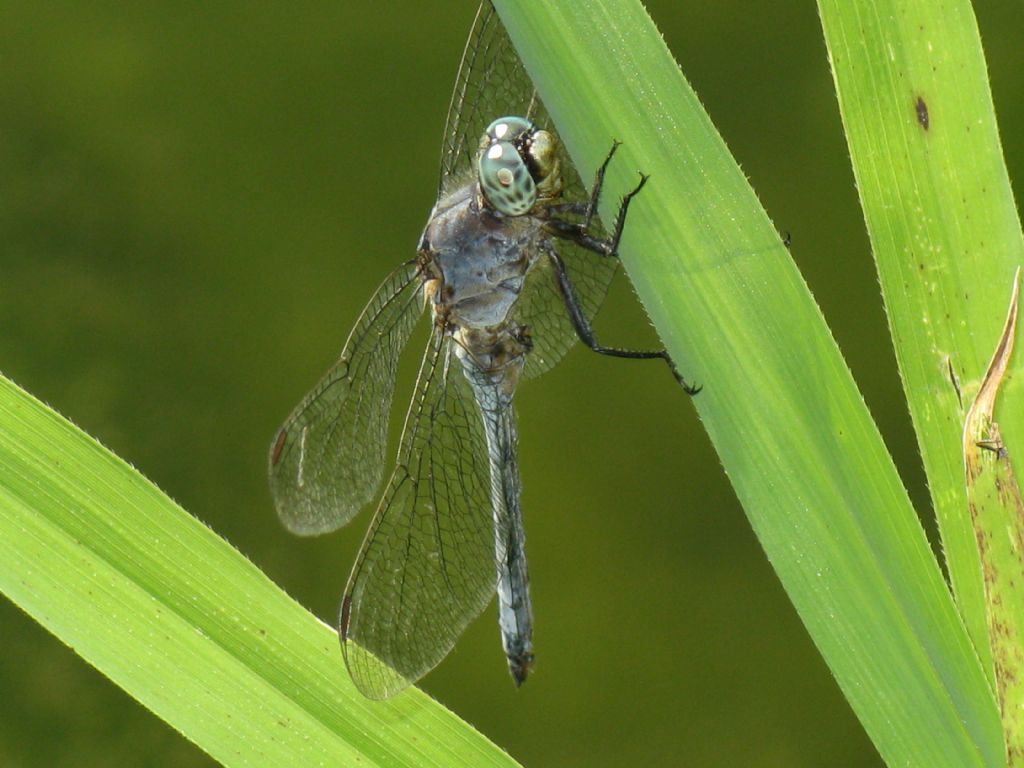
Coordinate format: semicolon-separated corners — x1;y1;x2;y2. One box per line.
818;0;1024;692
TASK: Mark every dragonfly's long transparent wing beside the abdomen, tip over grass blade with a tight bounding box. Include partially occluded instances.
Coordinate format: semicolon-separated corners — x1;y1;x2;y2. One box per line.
340;332;496;698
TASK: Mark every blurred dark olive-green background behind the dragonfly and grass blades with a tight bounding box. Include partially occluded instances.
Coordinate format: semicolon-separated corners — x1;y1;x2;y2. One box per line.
0;0;1024;768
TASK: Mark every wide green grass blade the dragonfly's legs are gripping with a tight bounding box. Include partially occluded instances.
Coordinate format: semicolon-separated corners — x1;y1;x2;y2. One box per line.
498;0;1002;768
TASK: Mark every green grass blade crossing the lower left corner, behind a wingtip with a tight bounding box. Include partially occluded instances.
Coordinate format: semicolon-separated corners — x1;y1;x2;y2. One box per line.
0;378;514;767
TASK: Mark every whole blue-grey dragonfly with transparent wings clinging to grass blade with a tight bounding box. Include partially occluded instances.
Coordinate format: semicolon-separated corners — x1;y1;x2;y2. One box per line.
269;2;699;699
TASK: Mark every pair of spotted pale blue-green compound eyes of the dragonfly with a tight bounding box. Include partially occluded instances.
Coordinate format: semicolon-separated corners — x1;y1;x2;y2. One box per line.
477;117;537;216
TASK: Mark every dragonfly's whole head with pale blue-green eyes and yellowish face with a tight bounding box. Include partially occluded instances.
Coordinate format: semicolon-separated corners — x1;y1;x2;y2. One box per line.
477;117;562;216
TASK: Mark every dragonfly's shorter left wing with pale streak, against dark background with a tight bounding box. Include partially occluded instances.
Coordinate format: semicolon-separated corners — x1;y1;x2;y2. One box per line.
269;262;423;536
